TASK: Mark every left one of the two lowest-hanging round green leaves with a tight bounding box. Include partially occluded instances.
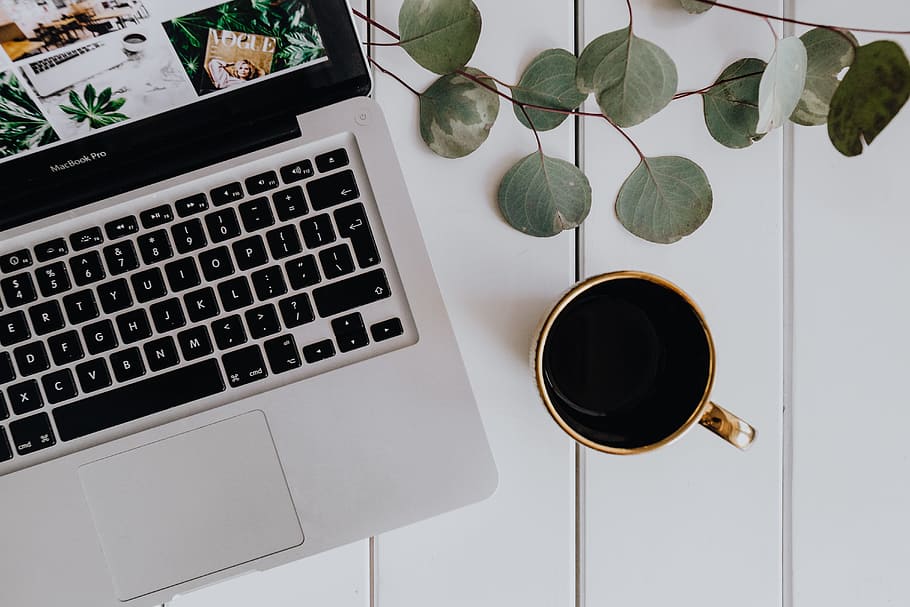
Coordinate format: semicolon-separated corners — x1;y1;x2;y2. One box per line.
498;152;591;236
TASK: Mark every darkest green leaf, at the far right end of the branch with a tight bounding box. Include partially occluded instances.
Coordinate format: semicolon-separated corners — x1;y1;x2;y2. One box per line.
828;40;910;156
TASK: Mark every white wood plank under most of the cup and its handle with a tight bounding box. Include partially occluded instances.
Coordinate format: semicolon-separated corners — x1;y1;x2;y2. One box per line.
584;0;783;607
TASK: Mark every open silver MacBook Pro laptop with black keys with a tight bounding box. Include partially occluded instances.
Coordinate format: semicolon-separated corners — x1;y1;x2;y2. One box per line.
0;0;497;607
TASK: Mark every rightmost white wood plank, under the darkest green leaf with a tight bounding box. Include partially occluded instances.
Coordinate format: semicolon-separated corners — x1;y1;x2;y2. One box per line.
792;0;910;607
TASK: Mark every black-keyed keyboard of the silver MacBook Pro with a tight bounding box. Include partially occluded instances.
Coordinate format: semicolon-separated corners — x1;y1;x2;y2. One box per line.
0;148;405;468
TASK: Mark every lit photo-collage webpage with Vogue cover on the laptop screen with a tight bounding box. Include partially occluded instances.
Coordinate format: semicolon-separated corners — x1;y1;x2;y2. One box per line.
0;0;327;163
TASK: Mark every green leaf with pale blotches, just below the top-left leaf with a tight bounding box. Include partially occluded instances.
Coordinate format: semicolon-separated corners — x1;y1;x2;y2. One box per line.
420;67;499;158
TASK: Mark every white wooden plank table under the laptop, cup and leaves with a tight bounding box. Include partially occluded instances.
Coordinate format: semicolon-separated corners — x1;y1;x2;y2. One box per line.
173;0;910;607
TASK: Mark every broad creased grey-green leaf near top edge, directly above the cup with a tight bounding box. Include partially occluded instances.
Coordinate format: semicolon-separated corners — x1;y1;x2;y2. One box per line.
576;27;677;127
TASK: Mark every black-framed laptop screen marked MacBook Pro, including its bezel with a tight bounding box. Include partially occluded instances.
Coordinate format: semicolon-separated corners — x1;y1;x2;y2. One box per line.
0;0;369;229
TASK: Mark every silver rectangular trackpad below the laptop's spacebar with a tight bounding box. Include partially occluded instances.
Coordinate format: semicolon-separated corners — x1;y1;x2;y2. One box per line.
79;411;303;601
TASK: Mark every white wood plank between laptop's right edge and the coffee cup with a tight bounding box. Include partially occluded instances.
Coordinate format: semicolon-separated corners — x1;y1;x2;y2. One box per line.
376;0;574;607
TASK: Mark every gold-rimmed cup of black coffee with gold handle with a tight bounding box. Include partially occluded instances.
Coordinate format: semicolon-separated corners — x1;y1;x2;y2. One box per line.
533;271;755;455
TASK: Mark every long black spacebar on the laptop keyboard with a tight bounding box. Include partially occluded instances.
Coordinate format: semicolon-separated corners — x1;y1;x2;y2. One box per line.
53;358;224;441
